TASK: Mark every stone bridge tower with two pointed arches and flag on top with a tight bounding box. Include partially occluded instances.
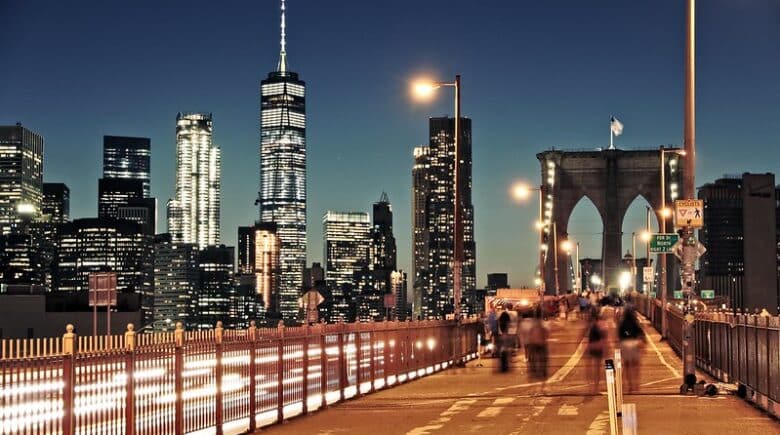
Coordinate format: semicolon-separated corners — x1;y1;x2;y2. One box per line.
536;148;682;294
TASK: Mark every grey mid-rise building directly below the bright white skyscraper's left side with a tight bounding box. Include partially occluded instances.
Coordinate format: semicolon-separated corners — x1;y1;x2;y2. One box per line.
153;234;200;331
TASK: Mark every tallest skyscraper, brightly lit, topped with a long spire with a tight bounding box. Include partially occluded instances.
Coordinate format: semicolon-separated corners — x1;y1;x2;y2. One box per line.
258;0;306;323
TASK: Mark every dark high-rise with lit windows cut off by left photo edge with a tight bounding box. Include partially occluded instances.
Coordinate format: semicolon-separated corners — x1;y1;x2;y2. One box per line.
0;124;43;234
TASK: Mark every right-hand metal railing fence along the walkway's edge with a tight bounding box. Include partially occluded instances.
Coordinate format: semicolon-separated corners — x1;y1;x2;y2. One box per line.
636;295;780;416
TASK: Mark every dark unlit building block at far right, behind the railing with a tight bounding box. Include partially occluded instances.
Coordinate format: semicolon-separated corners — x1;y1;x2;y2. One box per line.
699;173;780;314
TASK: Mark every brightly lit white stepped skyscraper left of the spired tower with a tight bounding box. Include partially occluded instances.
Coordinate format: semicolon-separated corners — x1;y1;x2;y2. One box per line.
168;113;221;249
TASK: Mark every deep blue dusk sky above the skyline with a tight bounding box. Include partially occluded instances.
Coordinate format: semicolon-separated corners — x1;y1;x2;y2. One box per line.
0;0;780;285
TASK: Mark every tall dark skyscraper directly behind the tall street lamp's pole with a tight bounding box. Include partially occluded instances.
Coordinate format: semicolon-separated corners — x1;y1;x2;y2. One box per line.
412;117;477;318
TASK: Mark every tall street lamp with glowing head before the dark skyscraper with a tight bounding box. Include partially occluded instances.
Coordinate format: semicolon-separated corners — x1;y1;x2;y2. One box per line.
412;74;463;319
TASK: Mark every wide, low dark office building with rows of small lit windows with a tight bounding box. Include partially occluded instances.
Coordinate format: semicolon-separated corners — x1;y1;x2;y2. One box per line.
54;218;154;321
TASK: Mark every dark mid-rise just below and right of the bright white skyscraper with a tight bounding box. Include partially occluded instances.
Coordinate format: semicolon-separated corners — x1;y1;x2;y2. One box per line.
190;245;234;329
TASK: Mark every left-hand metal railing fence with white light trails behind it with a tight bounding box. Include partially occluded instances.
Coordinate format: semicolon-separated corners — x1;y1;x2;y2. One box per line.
0;320;477;435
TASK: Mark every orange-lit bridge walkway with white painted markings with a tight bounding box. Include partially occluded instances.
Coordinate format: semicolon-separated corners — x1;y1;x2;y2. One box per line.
263;320;780;435
